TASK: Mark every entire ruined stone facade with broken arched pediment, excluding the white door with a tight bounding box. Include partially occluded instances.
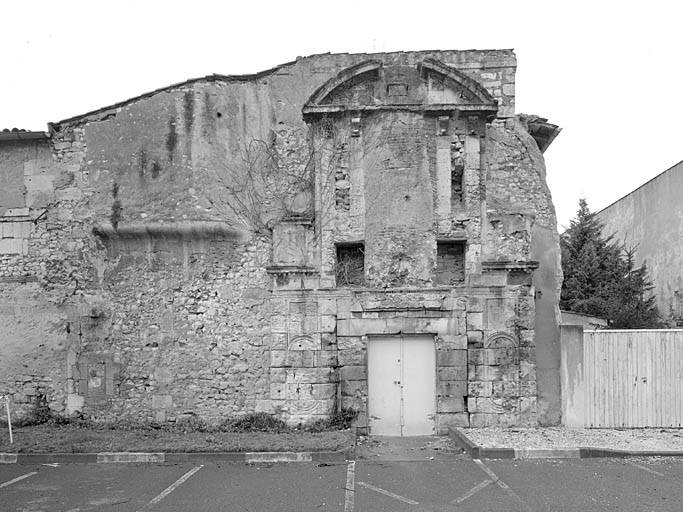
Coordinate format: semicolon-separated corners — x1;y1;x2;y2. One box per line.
0;50;561;432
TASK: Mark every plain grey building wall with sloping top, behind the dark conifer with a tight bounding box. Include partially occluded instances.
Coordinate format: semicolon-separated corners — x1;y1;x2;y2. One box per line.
597;162;683;323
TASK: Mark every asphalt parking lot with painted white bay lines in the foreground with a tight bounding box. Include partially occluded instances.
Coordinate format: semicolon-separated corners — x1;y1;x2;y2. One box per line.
0;454;683;512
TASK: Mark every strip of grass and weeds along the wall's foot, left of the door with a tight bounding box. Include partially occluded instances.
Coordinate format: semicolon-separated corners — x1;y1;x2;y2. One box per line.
0;410;356;453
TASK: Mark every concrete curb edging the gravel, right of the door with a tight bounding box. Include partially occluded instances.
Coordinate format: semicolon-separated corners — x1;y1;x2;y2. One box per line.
448;427;683;459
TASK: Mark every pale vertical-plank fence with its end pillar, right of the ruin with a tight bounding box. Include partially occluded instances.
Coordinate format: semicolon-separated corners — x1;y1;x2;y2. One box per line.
560;326;683;427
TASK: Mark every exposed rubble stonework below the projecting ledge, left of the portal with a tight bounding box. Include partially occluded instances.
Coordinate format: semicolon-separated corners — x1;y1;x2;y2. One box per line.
67;234;271;422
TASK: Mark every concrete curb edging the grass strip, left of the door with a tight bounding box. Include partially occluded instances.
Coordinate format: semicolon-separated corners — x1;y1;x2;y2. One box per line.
0;449;353;464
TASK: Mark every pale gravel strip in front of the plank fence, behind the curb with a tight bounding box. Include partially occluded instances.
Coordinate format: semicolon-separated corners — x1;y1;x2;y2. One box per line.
461;427;683;451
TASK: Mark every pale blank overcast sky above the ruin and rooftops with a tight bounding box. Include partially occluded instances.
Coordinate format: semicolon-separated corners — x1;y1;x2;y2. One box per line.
0;0;683;230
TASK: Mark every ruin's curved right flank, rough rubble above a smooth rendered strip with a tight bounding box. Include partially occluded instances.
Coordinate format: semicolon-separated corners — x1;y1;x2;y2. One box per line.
484;116;562;425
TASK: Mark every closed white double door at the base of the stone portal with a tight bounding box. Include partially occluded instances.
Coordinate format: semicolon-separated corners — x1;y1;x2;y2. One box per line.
368;336;436;436
